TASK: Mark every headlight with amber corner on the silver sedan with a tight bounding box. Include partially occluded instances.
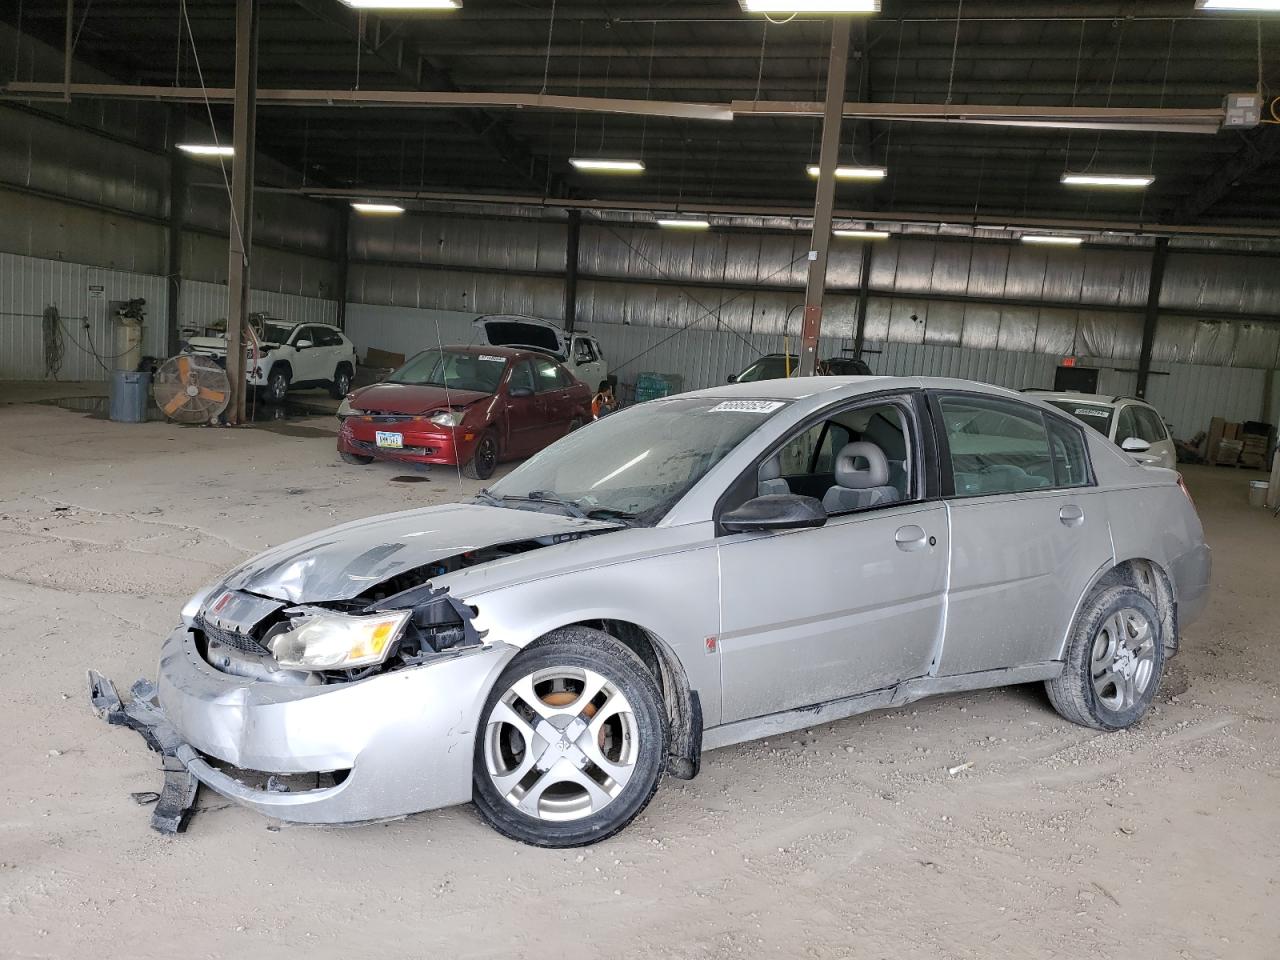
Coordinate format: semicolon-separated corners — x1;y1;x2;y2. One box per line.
266;611;412;669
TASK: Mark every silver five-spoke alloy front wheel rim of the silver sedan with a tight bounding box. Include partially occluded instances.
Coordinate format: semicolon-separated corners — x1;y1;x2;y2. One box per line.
484;667;640;820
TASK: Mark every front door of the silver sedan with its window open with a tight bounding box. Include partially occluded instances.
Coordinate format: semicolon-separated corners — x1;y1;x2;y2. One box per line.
718;396;948;722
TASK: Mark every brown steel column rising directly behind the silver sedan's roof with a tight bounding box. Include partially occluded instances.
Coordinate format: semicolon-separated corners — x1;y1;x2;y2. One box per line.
800;17;849;376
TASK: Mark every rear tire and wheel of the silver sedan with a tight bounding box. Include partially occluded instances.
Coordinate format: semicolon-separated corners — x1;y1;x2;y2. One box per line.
1044;586;1165;731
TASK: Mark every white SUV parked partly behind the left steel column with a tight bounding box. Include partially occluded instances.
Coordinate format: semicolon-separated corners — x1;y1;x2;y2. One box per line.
187;317;356;403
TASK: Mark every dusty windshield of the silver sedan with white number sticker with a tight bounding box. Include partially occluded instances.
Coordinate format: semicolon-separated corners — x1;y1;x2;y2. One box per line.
489;397;786;524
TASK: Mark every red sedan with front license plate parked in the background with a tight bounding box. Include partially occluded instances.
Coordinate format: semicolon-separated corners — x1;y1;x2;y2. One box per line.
338;347;591;480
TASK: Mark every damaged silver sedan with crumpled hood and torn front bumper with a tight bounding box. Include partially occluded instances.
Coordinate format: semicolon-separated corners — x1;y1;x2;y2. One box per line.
90;378;1210;846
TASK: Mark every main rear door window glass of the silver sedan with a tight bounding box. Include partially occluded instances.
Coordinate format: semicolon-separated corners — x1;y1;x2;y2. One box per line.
938;394;1057;497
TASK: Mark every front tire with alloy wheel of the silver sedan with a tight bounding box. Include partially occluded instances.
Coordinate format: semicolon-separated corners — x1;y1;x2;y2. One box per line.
472;627;668;847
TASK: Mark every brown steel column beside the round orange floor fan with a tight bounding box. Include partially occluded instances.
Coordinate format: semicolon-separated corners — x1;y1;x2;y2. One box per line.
227;0;257;424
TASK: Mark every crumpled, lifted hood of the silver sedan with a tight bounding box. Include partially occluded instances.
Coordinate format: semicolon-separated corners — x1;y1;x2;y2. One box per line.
220;503;620;603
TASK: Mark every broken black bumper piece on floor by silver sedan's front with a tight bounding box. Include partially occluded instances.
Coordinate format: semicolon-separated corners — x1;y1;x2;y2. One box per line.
88;669;200;835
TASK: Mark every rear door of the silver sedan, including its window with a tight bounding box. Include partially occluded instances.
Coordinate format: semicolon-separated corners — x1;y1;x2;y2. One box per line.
933;393;1112;676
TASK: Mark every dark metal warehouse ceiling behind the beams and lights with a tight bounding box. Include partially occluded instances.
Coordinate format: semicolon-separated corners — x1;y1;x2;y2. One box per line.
4;0;1280;225
